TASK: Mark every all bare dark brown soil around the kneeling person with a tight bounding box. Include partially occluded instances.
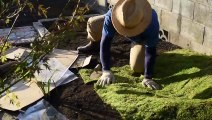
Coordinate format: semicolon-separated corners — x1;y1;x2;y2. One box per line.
48;31;180;120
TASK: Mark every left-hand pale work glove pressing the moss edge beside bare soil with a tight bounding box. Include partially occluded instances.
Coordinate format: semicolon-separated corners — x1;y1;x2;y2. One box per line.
96;71;115;87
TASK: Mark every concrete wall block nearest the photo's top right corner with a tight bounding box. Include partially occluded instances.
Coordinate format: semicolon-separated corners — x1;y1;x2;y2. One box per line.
194;3;209;24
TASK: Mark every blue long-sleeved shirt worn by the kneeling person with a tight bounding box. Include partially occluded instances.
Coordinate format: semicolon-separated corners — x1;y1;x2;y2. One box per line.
100;9;159;70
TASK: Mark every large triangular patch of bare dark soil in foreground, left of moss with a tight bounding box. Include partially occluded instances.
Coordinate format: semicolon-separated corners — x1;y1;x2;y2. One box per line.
48;78;121;120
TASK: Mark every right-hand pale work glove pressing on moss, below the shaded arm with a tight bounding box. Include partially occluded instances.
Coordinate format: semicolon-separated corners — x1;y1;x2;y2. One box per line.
142;78;161;90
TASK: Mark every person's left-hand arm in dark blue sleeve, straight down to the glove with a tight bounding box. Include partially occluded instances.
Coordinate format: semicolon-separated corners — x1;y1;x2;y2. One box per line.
100;10;115;71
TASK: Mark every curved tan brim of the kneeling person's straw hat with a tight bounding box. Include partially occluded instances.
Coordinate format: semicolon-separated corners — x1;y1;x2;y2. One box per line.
111;0;152;37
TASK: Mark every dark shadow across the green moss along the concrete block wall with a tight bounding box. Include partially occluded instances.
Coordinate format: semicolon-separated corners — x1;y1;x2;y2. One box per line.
155;52;212;84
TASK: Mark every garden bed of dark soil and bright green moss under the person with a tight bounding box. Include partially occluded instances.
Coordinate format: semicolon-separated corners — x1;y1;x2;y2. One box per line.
49;30;212;120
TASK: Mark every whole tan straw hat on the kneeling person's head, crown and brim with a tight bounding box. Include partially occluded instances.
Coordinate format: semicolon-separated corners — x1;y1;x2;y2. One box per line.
112;0;152;37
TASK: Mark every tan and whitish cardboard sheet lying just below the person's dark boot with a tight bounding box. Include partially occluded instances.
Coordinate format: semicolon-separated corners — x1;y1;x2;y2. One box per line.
34;49;78;83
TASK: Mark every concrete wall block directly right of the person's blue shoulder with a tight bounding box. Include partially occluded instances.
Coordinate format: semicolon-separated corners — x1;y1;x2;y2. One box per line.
161;10;181;33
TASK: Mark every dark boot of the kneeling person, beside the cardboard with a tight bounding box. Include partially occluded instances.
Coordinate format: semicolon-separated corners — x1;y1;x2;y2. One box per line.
77;42;100;54
